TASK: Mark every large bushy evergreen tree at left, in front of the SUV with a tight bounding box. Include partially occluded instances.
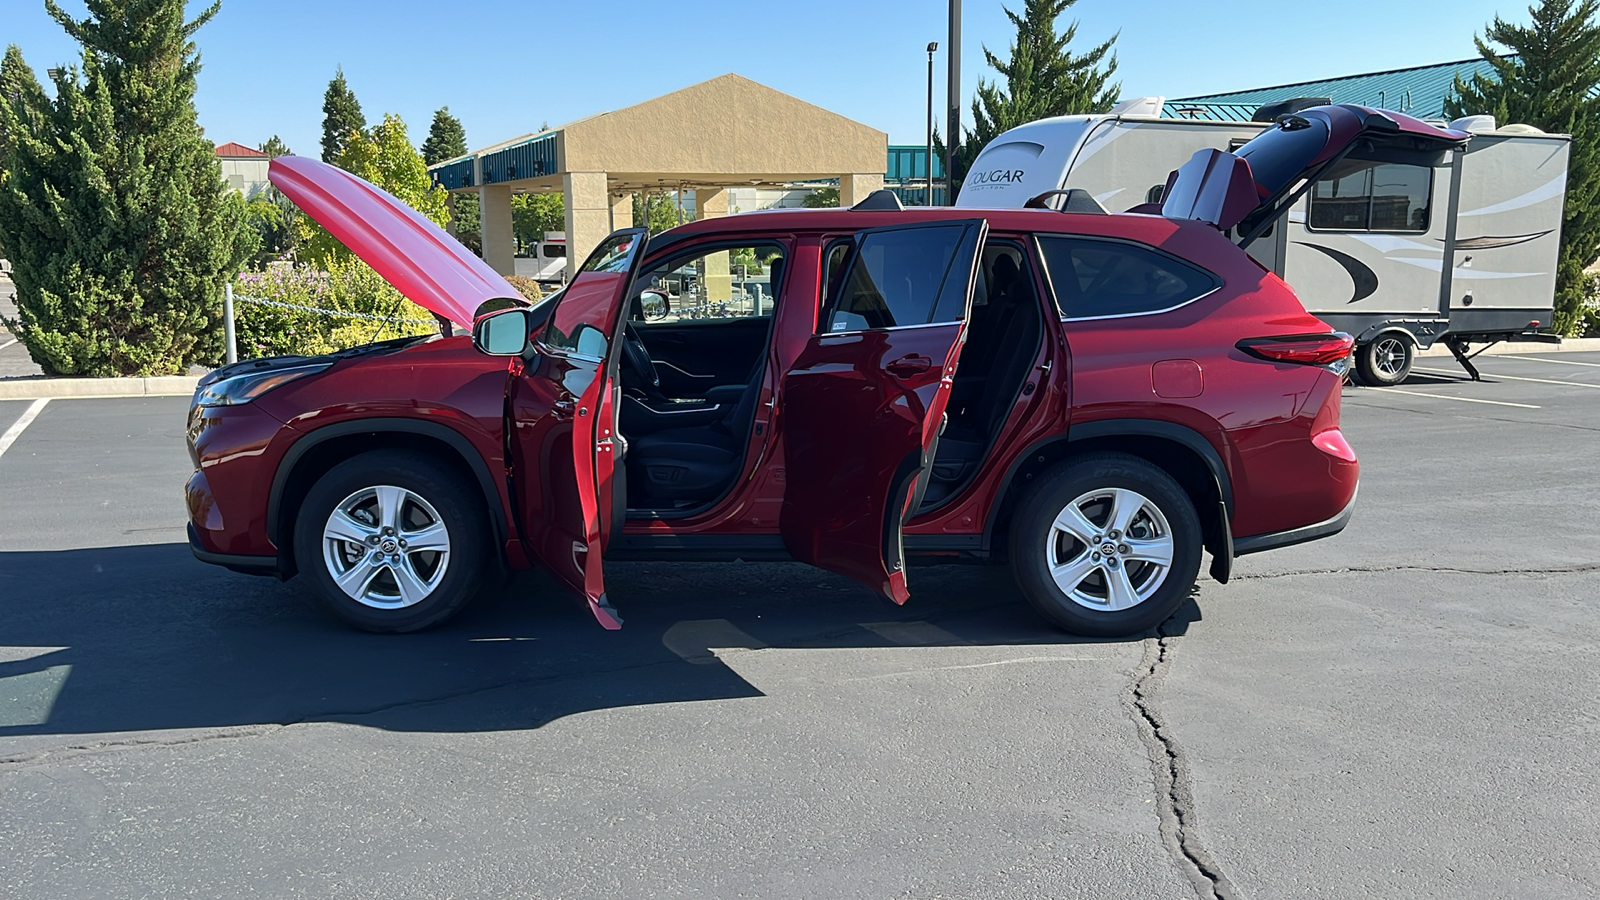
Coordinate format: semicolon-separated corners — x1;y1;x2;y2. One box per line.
0;0;254;375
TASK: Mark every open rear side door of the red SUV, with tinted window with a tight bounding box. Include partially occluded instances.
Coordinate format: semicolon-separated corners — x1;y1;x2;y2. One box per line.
779;219;989;604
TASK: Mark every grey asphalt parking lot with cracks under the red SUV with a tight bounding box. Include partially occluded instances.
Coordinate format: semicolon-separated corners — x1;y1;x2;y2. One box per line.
0;352;1600;900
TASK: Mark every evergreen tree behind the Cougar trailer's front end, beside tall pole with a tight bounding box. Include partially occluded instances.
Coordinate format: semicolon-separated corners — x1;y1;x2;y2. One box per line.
934;0;1122;200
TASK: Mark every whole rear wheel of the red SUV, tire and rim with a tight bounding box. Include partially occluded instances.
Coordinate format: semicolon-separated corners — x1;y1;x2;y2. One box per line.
1010;453;1203;637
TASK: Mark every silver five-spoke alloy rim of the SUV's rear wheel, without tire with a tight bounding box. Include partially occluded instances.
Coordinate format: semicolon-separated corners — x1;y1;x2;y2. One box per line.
1045;488;1174;612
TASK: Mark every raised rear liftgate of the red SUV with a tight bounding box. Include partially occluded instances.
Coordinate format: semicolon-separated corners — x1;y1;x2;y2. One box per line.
1162;104;1472;237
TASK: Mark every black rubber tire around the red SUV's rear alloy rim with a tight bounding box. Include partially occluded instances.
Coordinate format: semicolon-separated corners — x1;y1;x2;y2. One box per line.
1010;453;1203;637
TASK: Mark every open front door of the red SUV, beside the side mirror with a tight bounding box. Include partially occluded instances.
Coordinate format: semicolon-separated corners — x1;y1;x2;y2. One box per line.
506;229;645;629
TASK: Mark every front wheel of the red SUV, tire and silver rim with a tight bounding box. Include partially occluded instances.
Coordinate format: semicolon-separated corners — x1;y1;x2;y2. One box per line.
294;450;490;633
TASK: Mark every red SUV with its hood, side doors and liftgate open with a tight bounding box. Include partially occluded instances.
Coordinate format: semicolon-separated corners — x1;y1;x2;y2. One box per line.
187;110;1454;636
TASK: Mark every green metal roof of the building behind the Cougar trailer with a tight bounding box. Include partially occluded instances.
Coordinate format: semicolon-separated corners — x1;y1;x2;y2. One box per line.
1162;58;1493;122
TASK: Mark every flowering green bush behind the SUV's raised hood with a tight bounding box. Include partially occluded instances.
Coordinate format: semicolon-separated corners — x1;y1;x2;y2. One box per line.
234;259;438;359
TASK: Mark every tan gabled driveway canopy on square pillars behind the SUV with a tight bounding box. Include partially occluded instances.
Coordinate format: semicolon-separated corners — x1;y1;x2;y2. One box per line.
429;74;888;275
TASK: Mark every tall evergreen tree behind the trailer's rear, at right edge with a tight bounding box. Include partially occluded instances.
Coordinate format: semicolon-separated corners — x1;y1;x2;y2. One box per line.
1445;0;1600;335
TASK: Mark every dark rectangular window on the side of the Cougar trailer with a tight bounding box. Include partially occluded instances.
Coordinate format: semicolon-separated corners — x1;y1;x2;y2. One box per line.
1306;163;1434;232
